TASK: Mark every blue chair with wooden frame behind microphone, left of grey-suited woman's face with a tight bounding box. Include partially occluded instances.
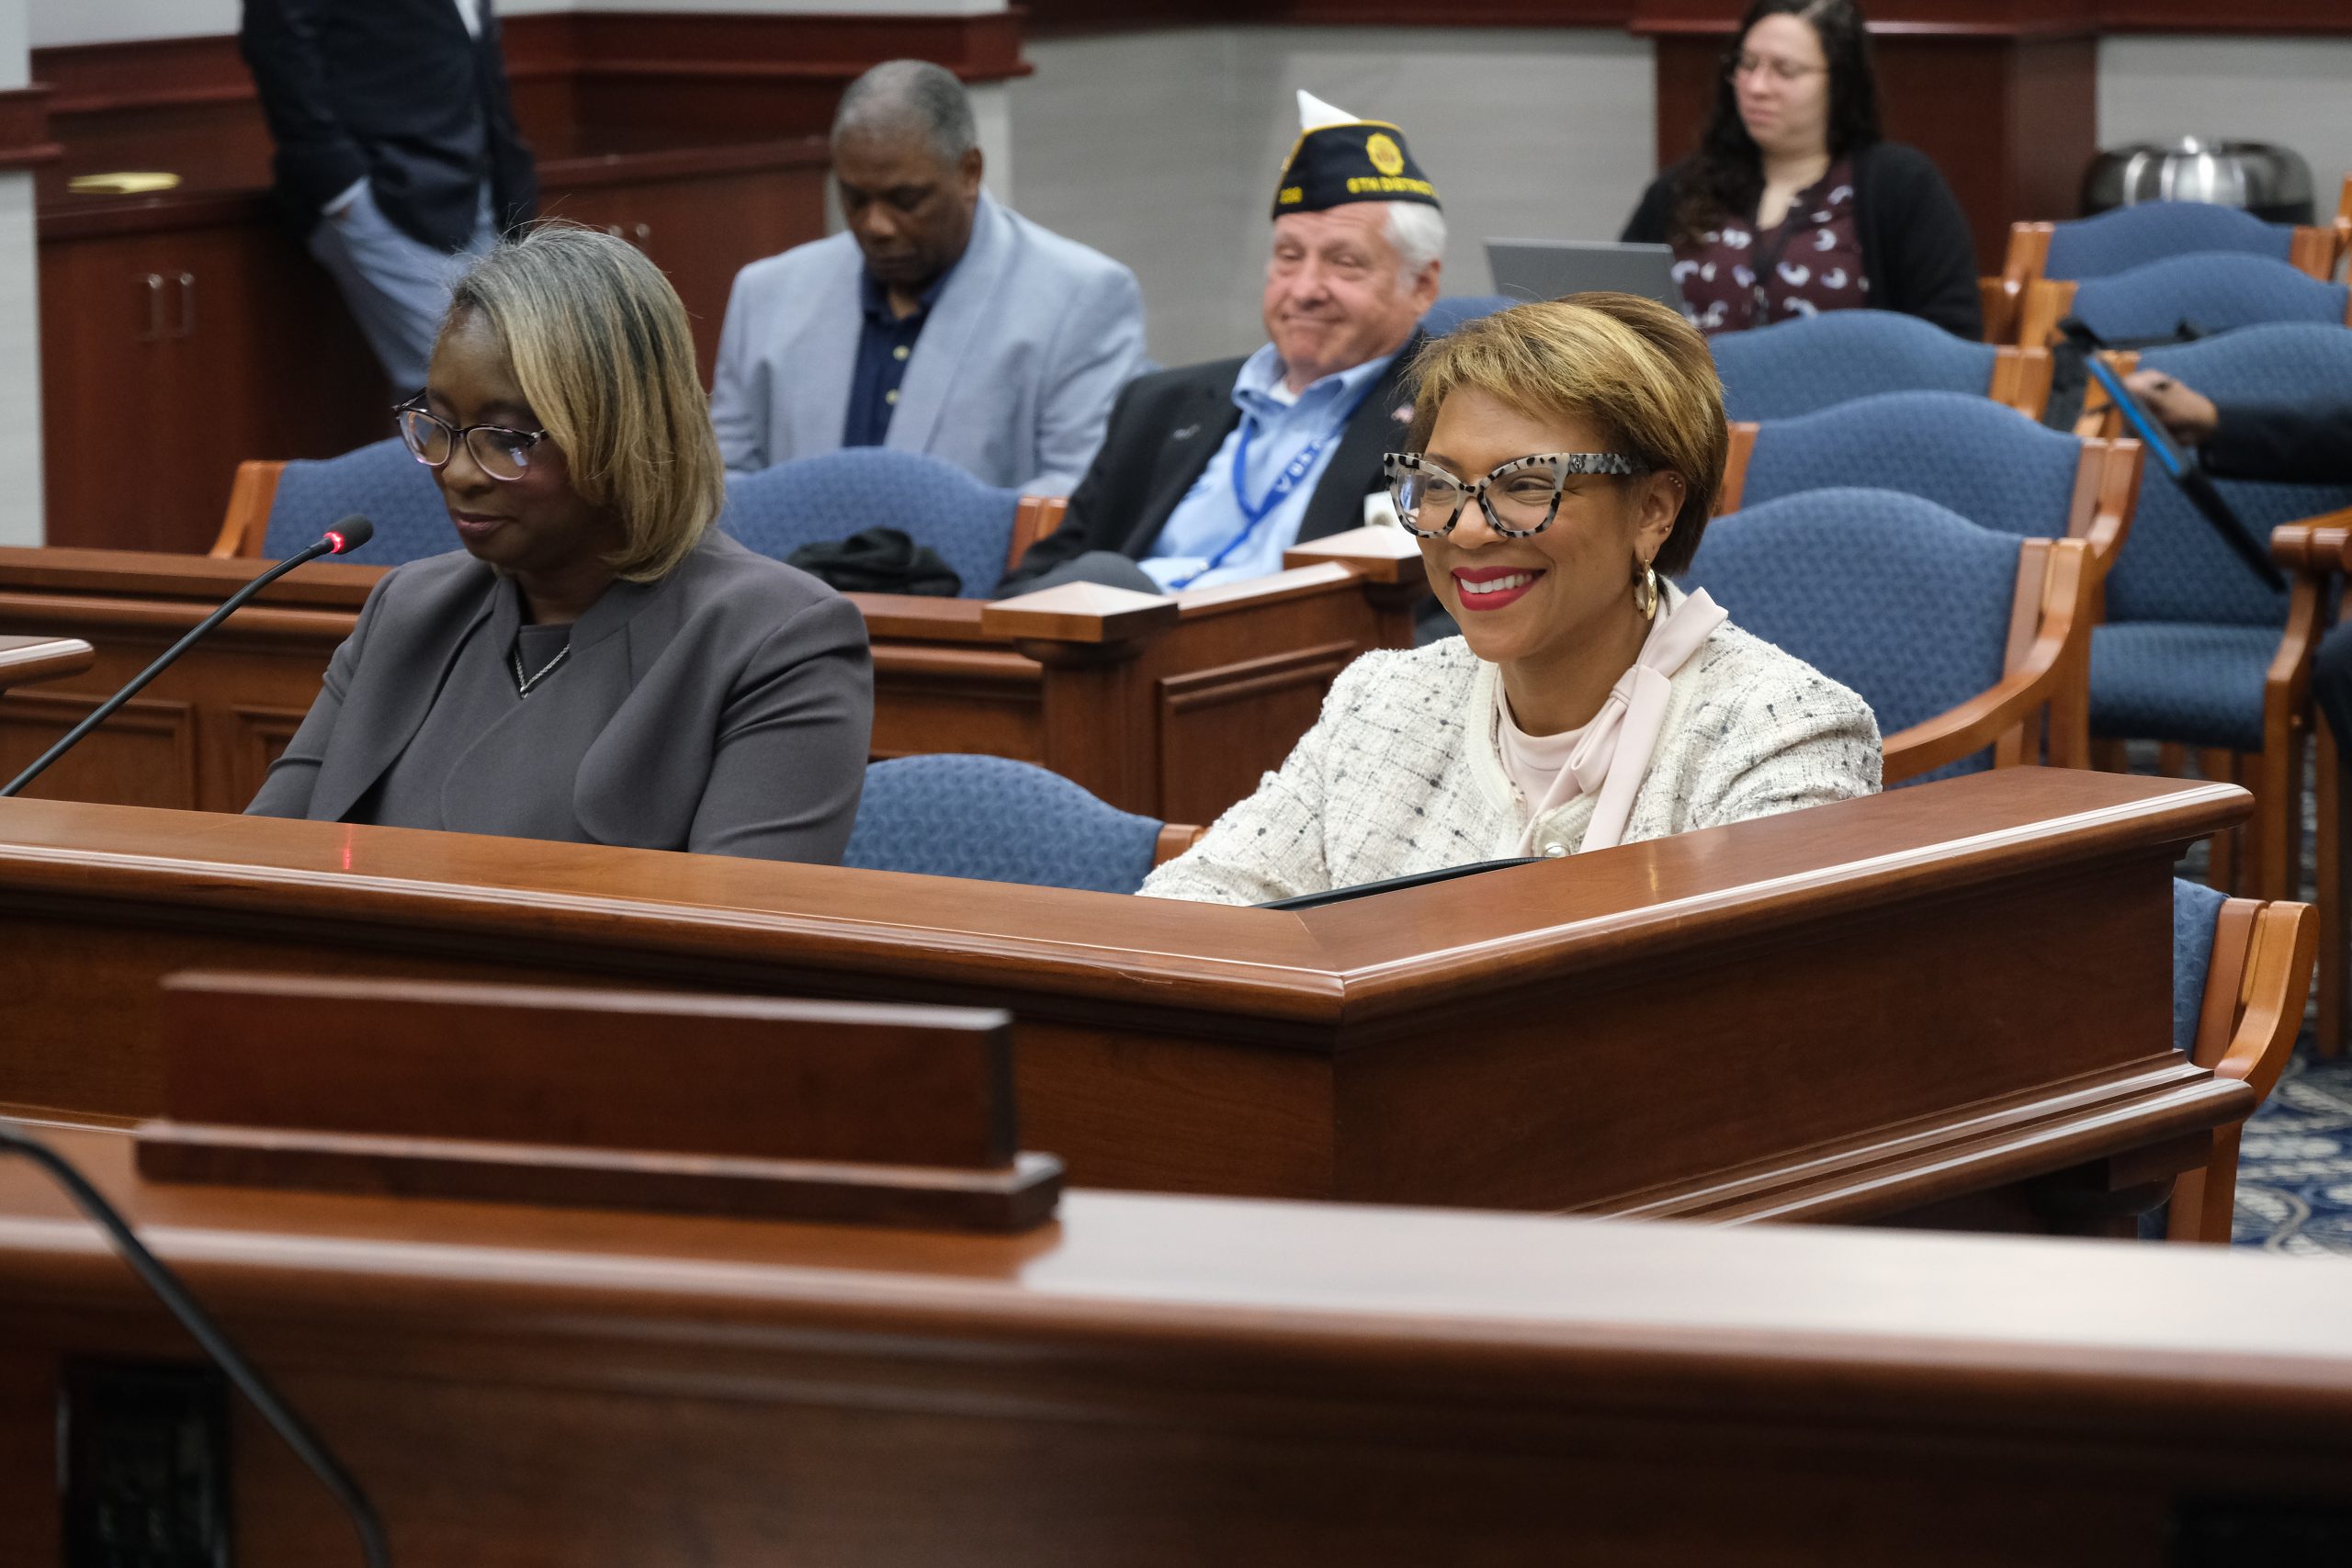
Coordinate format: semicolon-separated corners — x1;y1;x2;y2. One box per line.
211;437;461;567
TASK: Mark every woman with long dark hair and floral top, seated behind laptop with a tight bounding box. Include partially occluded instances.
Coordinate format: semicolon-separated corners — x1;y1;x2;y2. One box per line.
1623;0;1983;339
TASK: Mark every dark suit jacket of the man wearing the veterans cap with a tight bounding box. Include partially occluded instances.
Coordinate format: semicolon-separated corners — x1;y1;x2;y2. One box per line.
997;332;1423;594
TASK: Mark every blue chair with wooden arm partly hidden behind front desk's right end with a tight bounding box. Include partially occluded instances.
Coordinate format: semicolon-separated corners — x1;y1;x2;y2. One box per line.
2141;879;2319;1244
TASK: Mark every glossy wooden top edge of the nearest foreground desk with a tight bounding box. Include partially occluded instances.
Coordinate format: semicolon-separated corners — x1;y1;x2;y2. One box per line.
0;1131;2352;1438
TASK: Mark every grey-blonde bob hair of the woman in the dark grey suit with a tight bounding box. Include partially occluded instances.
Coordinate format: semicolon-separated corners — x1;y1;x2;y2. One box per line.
445;223;727;583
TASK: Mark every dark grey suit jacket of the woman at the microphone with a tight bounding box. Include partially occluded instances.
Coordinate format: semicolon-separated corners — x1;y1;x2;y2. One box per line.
247;529;873;861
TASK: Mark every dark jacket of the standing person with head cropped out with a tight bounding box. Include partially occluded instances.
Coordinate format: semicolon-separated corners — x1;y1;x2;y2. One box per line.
238;0;538;252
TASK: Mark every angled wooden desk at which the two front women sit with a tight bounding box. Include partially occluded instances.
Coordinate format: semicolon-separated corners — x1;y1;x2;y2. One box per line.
0;769;2253;1227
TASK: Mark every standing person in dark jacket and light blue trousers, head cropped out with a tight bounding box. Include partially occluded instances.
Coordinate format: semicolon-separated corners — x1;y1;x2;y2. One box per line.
238;0;538;392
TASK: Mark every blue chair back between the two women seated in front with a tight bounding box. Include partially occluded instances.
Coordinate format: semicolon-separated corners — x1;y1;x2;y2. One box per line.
842;752;1159;894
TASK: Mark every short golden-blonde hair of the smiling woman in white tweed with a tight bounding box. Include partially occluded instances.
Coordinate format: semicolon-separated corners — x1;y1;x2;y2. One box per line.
1407;294;1731;576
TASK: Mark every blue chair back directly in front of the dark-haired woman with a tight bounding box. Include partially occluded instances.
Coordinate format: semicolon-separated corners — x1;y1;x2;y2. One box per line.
1708;310;1999;421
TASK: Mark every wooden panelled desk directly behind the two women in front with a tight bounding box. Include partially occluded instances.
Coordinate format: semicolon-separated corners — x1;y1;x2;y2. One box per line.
0;543;1425;823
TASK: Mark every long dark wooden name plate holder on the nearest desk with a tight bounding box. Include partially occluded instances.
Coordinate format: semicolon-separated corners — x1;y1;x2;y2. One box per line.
136;974;1061;1232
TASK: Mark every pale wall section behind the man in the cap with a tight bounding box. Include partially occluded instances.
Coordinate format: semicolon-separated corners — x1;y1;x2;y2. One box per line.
1009;28;1654;365
